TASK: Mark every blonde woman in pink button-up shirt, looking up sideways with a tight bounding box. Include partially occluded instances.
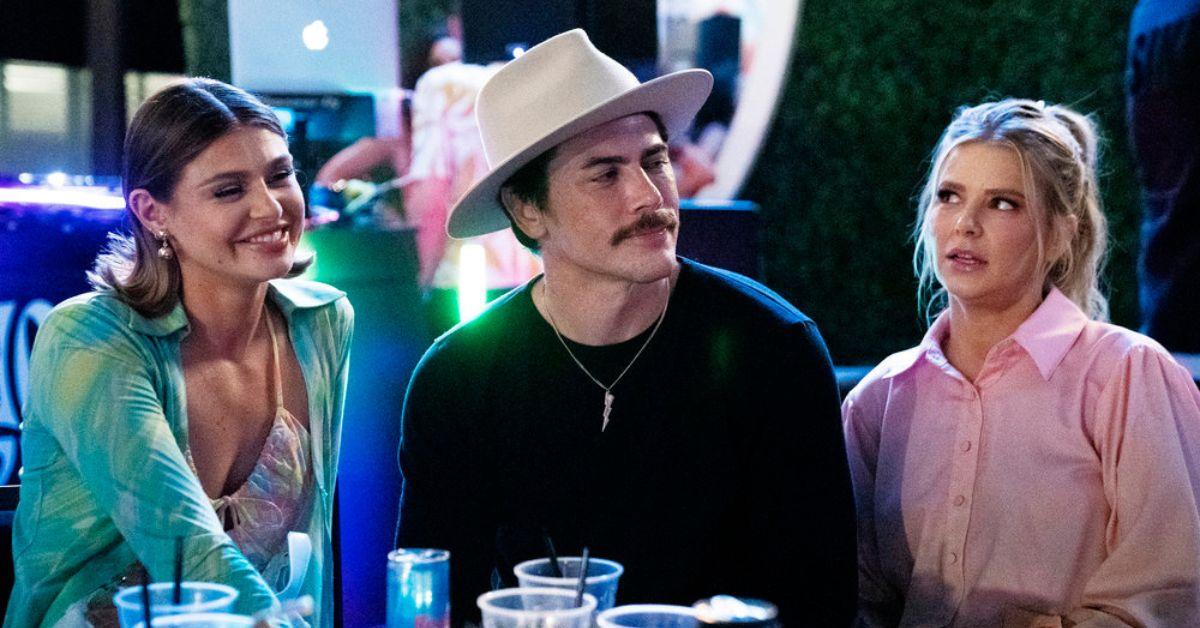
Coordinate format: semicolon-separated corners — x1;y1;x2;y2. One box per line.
842;100;1200;627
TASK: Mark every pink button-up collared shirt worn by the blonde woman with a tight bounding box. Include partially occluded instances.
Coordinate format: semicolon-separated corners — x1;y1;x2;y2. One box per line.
842;291;1200;627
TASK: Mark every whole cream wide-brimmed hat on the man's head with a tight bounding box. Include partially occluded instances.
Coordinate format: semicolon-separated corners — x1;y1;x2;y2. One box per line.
446;29;713;238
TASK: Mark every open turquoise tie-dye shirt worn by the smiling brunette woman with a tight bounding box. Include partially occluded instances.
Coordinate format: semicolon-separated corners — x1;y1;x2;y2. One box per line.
5;280;353;627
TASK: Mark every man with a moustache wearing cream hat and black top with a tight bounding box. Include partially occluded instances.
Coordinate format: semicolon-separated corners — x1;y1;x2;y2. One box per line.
397;30;856;626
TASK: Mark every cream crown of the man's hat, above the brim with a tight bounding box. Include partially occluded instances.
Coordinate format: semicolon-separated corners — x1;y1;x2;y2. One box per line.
475;29;641;167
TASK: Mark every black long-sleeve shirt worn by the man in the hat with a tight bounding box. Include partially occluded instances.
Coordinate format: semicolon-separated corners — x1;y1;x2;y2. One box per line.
397;259;857;626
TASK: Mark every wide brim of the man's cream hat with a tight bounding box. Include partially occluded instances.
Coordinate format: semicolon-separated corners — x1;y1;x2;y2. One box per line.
446;70;713;238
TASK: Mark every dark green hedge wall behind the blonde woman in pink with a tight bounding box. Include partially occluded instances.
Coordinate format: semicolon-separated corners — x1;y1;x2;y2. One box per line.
742;0;1138;364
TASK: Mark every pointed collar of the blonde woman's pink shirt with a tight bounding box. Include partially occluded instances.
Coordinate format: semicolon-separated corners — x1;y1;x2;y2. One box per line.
883;288;1087;379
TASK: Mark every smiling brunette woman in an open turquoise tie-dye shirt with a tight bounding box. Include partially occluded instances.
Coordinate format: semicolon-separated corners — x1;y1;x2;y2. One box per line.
5;79;353;627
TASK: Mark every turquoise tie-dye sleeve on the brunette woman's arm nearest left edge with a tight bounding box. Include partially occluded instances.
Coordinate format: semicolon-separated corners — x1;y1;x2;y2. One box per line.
29;306;276;612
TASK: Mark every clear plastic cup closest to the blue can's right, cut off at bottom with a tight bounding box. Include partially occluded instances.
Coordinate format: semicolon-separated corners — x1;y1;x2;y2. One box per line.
475;588;596;628
